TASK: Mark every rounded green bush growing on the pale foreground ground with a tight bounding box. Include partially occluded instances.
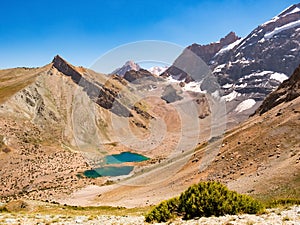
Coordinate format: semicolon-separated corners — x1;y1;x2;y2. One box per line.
145;182;263;222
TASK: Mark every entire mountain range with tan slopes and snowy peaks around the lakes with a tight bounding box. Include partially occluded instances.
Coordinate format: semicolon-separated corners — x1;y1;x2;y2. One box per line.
0;4;300;207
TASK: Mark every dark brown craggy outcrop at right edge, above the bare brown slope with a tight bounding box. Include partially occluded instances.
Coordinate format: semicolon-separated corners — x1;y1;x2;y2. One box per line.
256;65;300;115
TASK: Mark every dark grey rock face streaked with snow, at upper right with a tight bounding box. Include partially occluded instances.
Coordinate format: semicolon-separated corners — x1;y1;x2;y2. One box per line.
209;4;300;87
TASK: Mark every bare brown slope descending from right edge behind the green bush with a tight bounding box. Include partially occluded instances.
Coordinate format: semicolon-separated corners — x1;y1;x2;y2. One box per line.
62;64;300;207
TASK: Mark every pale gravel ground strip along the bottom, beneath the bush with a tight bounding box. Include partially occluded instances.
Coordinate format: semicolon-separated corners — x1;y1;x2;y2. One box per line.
0;205;300;225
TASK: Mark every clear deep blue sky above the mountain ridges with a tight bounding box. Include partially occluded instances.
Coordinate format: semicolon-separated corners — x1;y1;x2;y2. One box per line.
0;0;299;68
